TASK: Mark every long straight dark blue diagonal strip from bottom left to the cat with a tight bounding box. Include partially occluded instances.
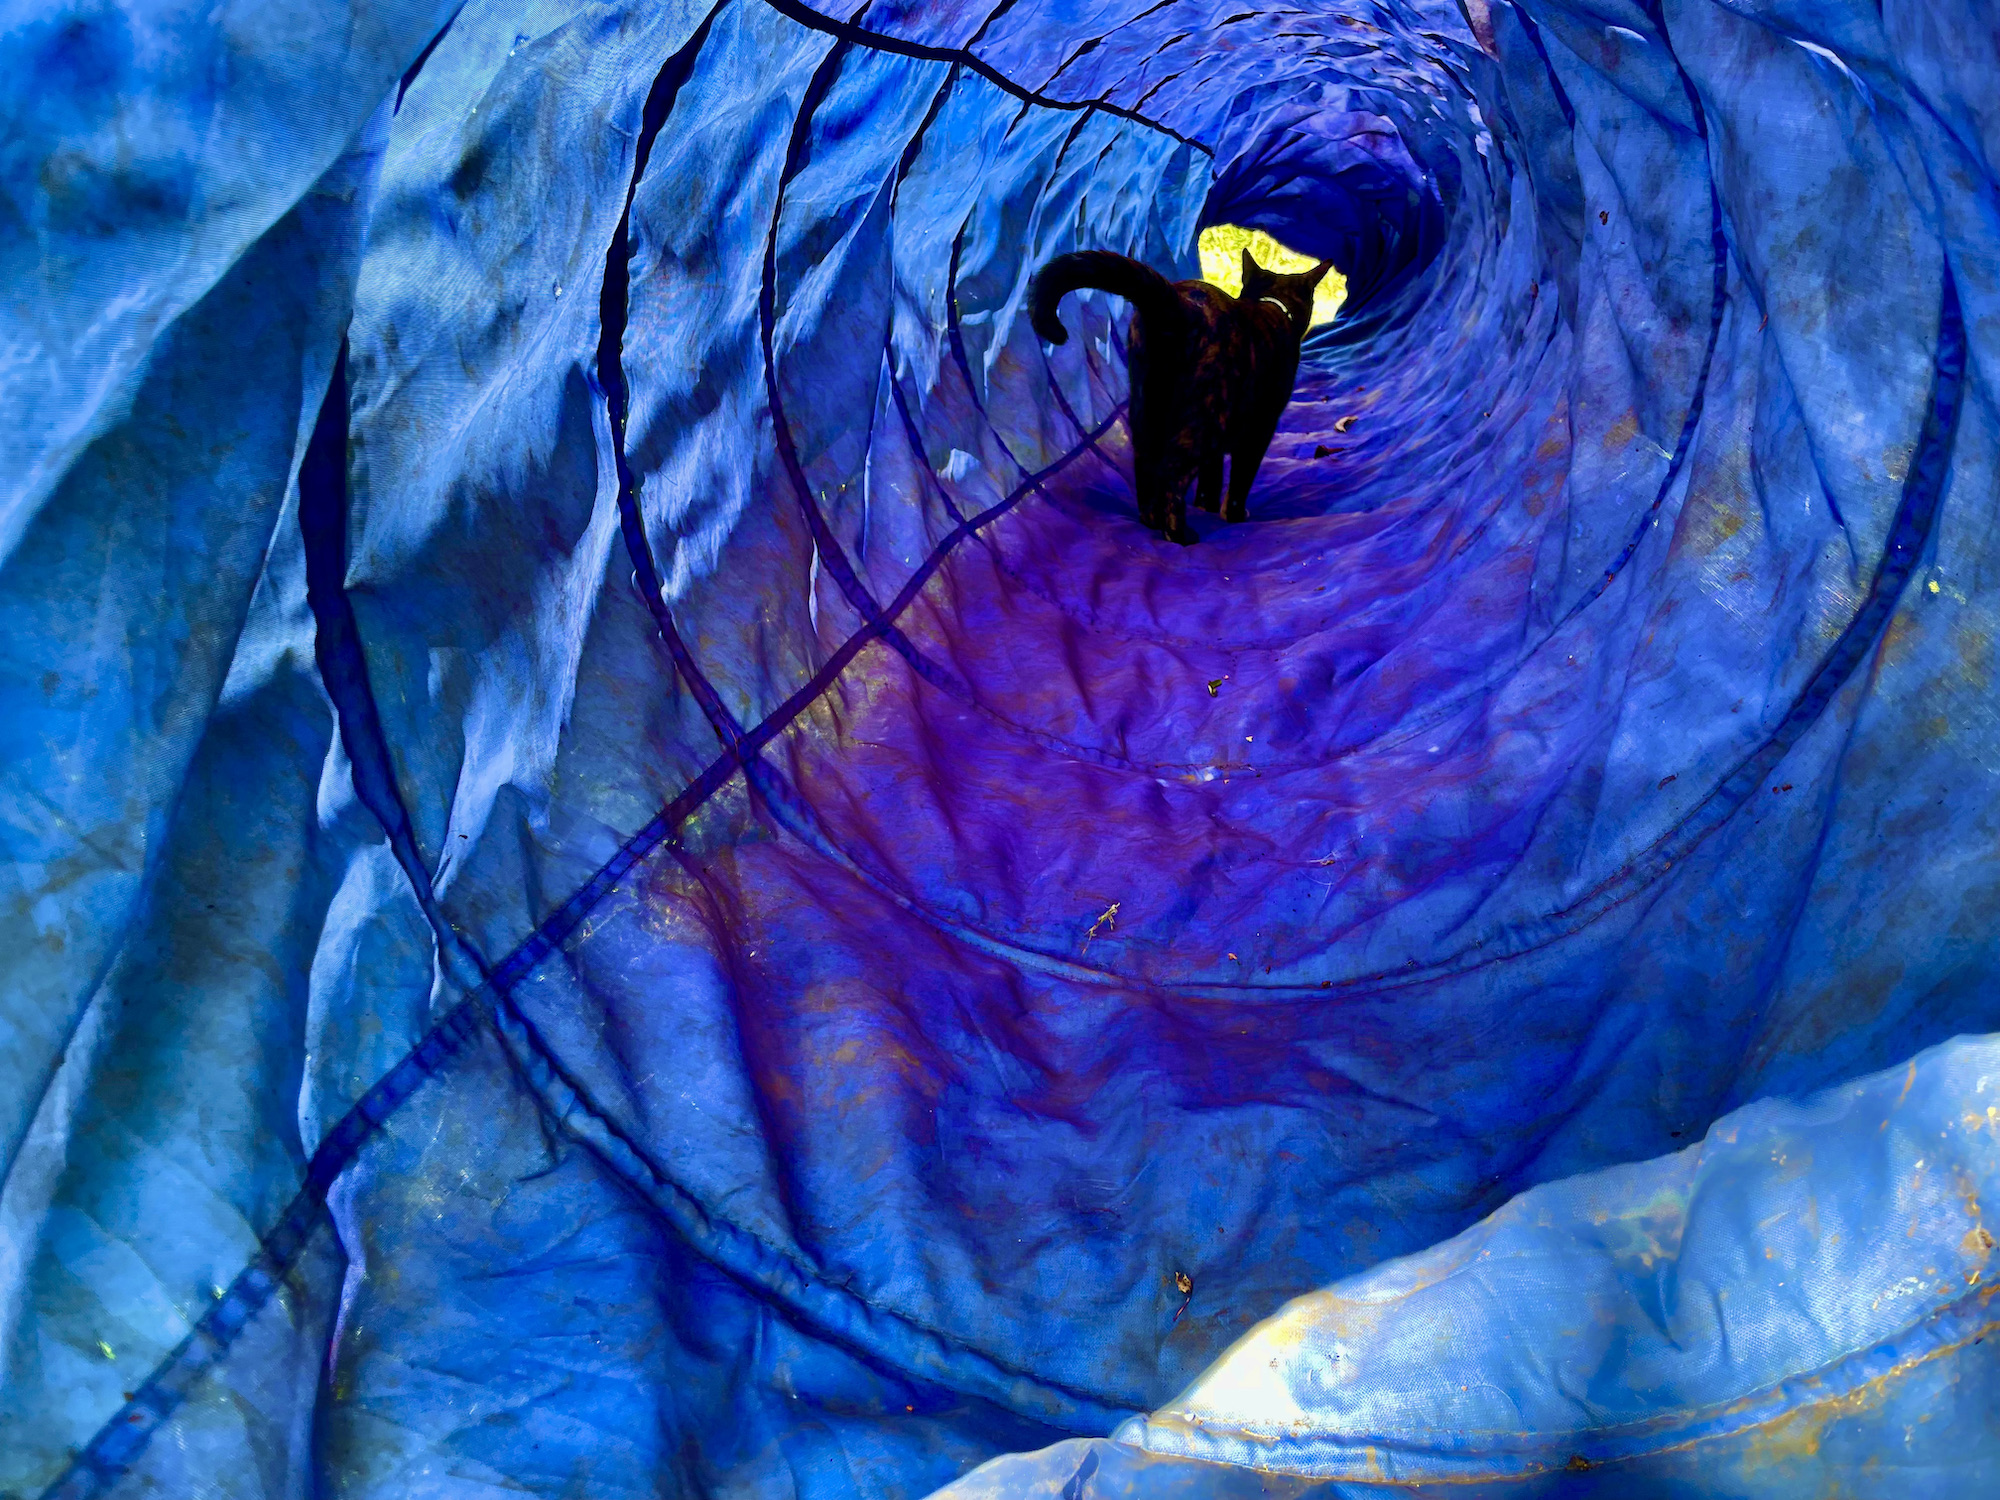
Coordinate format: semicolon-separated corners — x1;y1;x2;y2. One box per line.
44;390;1122;1500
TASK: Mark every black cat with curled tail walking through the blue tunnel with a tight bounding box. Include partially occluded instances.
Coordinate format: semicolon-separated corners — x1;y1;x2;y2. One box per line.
1028;250;1332;544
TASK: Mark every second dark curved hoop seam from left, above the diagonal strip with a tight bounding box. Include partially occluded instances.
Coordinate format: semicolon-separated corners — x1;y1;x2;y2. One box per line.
596;0;742;756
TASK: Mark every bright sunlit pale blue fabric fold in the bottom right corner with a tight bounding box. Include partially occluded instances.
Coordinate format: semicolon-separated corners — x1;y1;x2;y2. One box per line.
938;1038;2000;1500
